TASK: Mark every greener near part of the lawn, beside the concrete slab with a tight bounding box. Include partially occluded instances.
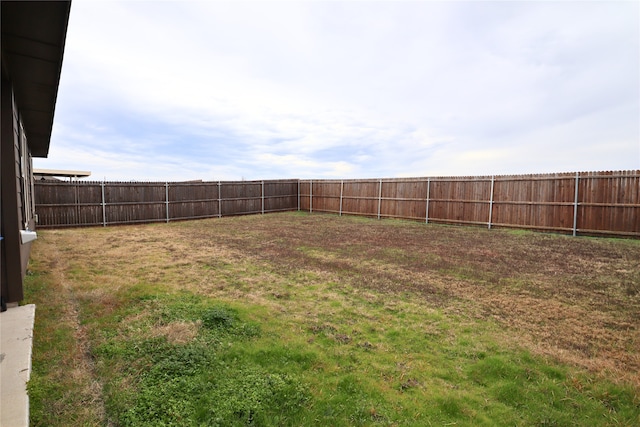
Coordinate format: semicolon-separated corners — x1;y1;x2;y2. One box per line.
26;215;640;426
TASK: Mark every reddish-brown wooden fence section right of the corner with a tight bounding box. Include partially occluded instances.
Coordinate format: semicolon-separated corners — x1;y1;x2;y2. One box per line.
300;170;640;237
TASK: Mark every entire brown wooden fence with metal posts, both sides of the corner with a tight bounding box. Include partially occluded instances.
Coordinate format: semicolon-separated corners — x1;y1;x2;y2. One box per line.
35;170;640;237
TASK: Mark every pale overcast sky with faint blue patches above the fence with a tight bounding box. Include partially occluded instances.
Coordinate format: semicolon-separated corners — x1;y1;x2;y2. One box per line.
34;0;640;181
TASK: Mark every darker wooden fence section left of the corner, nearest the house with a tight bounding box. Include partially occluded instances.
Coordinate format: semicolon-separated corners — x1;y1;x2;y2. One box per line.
34;180;299;228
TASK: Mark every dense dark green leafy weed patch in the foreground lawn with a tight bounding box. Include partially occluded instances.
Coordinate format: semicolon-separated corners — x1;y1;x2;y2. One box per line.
105;326;314;426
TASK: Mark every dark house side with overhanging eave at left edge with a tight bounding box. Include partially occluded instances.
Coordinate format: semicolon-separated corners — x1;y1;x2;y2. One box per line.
0;1;71;310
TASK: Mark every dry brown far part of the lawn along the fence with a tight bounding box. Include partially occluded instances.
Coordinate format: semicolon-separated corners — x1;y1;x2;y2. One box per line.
35;214;640;387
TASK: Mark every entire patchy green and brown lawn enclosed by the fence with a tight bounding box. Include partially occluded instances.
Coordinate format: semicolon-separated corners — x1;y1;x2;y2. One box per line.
26;213;640;426
